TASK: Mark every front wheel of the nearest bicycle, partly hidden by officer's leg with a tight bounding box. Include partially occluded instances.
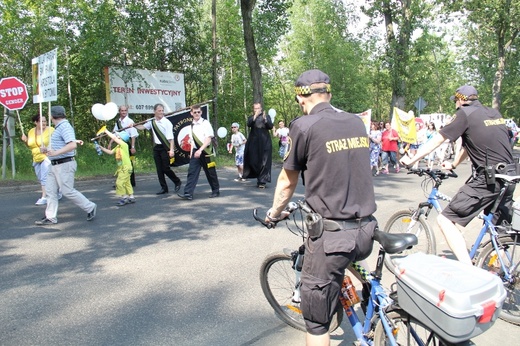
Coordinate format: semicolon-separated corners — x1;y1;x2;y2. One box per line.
260;253;343;332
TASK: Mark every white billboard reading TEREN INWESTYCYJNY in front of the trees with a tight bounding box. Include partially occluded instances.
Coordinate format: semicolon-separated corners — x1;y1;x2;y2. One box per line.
105;67;186;114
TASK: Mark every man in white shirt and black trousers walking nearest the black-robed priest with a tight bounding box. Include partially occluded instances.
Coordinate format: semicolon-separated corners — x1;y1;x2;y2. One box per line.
178;105;220;200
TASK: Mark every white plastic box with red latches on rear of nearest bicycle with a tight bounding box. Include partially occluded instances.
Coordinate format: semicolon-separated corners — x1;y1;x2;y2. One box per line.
397;253;506;343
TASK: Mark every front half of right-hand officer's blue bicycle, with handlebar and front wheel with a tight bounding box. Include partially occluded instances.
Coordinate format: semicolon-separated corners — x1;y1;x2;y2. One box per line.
384;168;458;272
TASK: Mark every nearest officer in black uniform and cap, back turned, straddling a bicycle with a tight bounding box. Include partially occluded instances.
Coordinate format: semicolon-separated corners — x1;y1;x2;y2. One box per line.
266;70;377;345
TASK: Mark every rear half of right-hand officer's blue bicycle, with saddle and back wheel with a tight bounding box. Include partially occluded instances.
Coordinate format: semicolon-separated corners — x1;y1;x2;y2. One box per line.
469;174;520;325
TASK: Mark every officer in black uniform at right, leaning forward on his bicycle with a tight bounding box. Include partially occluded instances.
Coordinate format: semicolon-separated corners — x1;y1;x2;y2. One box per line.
401;85;514;265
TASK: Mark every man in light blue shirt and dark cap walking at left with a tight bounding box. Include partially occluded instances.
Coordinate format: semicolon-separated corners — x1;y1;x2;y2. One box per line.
35;106;97;226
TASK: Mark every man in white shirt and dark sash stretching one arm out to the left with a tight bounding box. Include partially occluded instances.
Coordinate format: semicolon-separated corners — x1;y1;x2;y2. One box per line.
135;103;182;195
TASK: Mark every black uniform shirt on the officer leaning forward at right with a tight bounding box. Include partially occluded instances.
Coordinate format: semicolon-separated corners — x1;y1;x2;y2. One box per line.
439;101;513;168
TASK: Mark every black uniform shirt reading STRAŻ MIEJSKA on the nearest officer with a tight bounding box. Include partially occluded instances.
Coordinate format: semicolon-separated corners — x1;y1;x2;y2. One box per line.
284;102;376;220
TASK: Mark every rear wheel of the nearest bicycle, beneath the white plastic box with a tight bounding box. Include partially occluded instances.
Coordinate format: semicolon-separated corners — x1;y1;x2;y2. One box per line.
374;310;456;346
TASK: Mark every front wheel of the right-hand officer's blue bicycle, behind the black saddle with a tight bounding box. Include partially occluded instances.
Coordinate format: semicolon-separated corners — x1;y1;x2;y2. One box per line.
384;210;437;273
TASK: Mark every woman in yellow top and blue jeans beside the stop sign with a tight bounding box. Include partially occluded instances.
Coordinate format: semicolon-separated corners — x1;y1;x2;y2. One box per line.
22;114;54;205
